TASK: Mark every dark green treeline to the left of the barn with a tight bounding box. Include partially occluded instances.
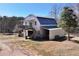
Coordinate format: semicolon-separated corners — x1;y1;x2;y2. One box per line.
0;16;24;33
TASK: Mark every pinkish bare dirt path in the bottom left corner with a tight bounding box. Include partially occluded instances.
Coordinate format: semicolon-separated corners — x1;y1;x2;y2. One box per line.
0;40;31;56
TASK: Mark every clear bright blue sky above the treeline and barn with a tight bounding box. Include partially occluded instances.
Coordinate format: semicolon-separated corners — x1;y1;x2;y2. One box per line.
0;3;72;17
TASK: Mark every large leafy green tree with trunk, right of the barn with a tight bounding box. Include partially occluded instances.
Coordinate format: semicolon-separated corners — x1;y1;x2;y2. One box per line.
60;7;77;40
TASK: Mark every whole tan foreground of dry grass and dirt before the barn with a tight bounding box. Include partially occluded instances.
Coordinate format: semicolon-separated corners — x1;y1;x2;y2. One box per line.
0;35;79;56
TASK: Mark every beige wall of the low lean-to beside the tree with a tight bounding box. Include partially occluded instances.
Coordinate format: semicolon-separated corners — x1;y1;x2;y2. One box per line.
49;28;65;40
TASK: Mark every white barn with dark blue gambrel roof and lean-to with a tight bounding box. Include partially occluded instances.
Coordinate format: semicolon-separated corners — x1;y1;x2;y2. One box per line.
23;15;63;39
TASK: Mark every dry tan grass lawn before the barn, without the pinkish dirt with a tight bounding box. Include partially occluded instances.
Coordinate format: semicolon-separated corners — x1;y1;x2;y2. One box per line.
0;35;79;56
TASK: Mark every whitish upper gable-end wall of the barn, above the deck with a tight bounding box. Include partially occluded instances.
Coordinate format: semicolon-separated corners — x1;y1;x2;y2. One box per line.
24;16;40;31
